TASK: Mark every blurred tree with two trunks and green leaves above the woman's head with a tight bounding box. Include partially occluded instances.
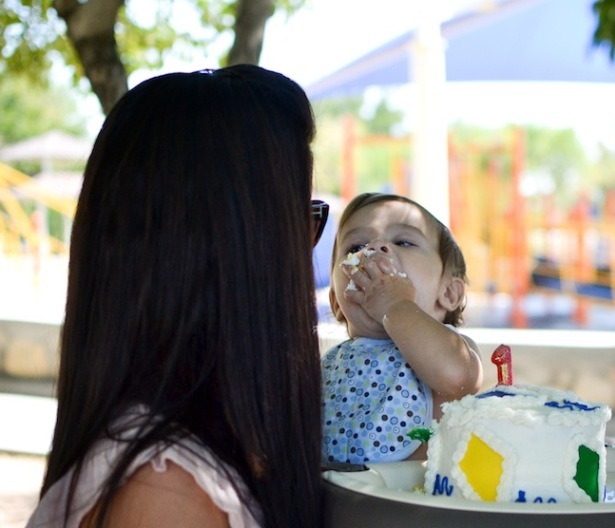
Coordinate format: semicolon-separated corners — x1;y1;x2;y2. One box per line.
0;0;304;114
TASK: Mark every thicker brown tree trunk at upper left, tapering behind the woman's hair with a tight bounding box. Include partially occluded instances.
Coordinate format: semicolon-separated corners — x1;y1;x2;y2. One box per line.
53;0;128;115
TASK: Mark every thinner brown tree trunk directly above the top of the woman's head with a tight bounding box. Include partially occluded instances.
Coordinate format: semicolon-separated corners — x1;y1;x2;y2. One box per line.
228;0;274;65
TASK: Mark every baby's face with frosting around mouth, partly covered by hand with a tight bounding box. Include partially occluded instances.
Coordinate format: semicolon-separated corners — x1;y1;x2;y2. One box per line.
332;201;443;335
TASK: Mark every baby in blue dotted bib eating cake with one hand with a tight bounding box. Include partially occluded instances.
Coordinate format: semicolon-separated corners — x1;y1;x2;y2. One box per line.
322;193;482;464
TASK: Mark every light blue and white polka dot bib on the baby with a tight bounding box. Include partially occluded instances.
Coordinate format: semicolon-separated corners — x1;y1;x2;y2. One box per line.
322;337;432;464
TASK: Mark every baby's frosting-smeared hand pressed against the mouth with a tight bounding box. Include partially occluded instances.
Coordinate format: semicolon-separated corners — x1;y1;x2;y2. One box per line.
341;248;415;323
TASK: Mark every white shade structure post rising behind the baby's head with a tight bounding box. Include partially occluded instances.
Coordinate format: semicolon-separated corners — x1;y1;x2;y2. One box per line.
409;2;450;226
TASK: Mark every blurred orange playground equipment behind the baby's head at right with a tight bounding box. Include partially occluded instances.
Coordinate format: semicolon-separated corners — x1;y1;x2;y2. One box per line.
341;118;615;328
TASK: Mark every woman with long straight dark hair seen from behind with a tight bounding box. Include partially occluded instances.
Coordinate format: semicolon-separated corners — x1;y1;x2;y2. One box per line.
28;65;326;528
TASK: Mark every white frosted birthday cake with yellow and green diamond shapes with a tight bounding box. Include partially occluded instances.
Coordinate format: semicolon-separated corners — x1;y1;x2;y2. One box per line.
425;385;611;503
